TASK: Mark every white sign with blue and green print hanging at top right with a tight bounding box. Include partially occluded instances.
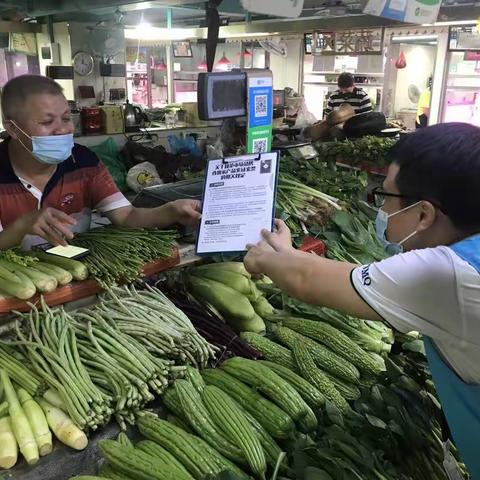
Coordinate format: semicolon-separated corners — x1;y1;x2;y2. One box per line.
363;0;442;24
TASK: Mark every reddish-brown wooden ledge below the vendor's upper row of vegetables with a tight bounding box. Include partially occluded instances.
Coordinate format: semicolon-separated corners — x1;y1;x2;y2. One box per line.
0;247;180;315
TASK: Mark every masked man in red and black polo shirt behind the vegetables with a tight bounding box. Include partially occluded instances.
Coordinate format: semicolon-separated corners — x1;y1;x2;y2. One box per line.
0;75;201;250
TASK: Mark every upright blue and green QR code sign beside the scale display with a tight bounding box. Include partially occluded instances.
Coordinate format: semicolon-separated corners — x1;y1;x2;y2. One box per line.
247;70;273;153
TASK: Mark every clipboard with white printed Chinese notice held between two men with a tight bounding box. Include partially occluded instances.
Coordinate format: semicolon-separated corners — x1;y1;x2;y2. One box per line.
197;152;279;254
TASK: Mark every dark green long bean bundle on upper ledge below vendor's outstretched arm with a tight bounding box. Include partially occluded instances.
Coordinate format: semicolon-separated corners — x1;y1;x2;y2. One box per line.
71;225;176;286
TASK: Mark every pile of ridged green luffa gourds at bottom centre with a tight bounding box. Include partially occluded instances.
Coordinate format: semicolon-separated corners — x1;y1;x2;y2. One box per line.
68;366;296;480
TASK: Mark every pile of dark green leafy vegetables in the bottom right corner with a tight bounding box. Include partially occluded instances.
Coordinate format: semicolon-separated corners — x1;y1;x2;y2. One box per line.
296;353;469;480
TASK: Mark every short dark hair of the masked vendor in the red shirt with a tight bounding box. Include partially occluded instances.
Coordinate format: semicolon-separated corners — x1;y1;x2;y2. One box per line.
1;75;63;120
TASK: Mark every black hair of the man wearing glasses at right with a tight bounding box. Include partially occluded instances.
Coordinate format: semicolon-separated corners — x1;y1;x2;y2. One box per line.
390;123;480;232
